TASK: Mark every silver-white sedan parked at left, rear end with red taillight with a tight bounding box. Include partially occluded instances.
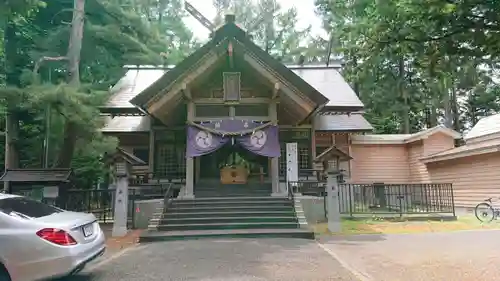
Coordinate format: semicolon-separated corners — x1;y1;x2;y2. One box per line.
0;193;106;281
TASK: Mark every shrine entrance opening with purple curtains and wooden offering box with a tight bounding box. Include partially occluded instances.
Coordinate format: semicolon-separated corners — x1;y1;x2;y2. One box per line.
186;122;280;184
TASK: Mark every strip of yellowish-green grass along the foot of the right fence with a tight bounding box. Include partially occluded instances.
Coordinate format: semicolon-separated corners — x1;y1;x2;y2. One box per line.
313;215;500;235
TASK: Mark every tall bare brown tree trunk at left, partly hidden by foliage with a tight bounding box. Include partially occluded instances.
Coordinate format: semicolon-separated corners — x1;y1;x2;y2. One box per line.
57;0;85;168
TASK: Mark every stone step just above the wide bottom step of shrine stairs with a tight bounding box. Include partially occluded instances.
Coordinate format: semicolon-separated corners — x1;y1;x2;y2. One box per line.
157;222;299;231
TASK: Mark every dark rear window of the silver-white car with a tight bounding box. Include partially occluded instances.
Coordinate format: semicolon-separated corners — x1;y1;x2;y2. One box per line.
0;197;62;218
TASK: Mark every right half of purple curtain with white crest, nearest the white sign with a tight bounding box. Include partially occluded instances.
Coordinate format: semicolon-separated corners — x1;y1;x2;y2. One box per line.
236;126;281;157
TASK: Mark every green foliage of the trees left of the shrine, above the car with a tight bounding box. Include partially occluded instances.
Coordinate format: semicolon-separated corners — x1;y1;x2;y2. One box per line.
0;0;197;187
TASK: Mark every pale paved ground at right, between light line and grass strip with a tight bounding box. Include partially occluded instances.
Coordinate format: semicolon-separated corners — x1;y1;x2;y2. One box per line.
321;230;500;281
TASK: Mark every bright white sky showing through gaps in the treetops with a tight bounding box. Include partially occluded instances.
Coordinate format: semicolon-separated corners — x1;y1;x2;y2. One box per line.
184;0;327;40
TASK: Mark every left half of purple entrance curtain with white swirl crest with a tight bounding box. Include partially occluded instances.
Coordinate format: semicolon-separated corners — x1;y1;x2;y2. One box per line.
186;126;230;157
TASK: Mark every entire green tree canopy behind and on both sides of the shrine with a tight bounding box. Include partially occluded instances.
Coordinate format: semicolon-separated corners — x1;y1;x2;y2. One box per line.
0;0;500;188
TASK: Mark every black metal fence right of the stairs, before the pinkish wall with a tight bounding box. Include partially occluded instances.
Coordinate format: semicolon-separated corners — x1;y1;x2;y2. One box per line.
288;181;455;216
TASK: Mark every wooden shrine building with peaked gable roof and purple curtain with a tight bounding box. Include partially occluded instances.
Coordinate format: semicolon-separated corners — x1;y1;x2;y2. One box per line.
101;13;373;198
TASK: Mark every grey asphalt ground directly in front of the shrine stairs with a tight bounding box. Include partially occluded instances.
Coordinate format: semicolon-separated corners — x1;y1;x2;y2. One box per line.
71;239;358;281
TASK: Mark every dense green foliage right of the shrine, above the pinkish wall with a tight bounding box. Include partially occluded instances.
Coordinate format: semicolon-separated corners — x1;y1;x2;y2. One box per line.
316;0;500;133
